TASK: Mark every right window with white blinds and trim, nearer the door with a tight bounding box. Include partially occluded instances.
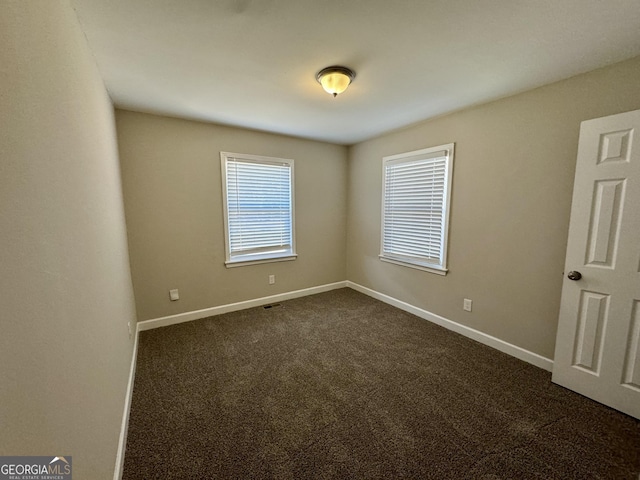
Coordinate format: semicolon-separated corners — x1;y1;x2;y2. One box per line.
380;143;453;275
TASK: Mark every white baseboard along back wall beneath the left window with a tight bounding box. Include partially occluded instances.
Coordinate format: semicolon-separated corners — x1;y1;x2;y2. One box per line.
138;281;347;331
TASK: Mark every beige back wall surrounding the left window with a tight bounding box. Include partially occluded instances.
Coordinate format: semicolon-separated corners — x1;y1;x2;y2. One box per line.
116;110;347;320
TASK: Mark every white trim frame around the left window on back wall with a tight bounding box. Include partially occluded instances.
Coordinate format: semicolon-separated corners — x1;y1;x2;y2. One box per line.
220;152;298;268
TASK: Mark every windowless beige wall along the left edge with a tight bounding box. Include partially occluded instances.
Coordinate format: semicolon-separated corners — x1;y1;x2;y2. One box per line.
0;0;135;479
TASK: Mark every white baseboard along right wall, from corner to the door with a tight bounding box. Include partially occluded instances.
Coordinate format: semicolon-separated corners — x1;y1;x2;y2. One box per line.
346;281;553;372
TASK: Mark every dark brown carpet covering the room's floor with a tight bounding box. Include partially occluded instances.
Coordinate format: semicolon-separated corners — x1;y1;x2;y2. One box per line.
123;289;640;480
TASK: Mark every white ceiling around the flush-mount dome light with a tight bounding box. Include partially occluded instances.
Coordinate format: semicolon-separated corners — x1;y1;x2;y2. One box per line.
72;0;640;144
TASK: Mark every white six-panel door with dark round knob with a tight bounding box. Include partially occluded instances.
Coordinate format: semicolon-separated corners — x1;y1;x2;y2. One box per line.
553;110;640;418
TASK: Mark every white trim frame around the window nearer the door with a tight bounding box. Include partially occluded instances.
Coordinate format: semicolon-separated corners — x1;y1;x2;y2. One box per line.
379;143;455;275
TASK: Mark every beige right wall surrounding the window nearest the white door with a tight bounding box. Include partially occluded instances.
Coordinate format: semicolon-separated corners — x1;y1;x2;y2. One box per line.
347;54;640;358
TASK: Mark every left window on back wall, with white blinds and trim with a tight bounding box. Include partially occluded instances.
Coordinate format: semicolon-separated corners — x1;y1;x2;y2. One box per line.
220;152;296;267
